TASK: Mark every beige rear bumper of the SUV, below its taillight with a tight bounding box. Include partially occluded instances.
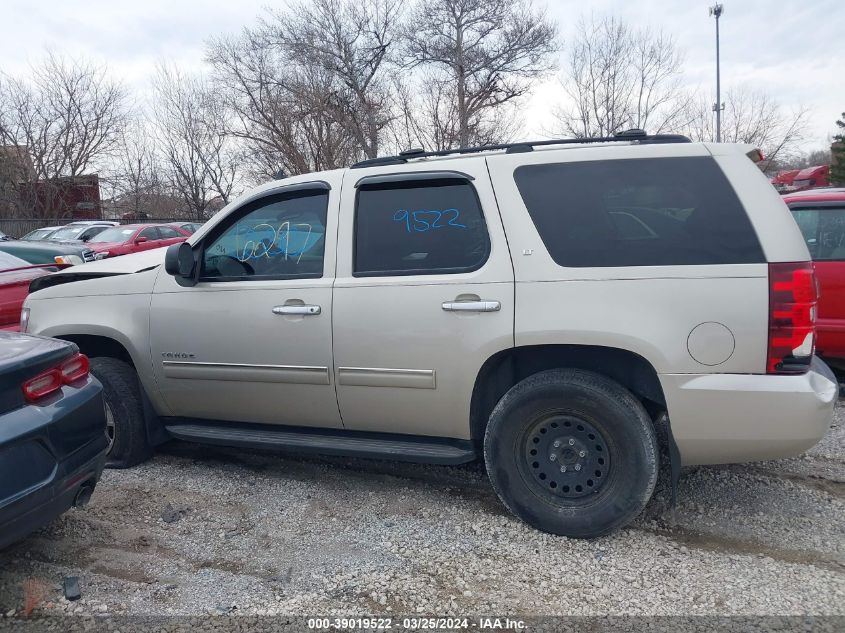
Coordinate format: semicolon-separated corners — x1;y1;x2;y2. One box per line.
660;359;839;466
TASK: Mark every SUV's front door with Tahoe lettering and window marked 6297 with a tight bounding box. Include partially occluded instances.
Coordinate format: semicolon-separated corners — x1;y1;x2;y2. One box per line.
150;178;341;427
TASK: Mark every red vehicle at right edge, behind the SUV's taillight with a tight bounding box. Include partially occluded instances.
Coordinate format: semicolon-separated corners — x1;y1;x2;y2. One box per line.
783;189;845;369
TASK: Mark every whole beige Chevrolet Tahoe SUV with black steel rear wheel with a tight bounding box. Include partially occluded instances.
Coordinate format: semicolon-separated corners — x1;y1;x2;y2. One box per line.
22;131;838;537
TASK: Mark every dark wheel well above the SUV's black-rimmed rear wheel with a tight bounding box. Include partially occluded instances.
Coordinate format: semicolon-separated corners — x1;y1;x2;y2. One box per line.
470;345;666;442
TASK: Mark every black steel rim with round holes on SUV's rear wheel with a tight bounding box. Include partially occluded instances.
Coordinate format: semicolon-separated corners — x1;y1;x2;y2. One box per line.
520;413;611;504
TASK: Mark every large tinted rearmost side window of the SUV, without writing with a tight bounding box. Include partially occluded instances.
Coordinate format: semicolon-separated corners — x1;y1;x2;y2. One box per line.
514;157;766;268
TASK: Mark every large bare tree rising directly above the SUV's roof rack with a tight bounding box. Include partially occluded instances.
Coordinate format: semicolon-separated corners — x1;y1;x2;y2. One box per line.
405;0;557;147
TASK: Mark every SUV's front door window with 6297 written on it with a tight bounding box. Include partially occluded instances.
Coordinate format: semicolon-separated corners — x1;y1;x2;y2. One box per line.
201;190;329;281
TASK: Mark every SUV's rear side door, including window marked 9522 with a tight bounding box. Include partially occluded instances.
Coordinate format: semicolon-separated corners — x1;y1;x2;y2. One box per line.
334;157;514;439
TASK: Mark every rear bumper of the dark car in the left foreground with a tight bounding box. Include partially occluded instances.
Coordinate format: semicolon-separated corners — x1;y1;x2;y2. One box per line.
0;378;107;549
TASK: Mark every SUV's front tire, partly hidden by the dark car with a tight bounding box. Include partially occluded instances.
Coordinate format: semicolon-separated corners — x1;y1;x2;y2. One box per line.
91;357;152;468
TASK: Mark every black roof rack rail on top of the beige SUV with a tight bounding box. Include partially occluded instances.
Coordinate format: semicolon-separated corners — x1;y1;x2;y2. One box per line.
351;128;692;169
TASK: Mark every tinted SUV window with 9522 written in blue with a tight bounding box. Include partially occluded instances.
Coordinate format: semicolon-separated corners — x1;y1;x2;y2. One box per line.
353;179;490;277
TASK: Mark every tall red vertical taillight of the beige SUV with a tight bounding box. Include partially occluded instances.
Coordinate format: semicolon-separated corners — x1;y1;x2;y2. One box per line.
766;262;818;374
